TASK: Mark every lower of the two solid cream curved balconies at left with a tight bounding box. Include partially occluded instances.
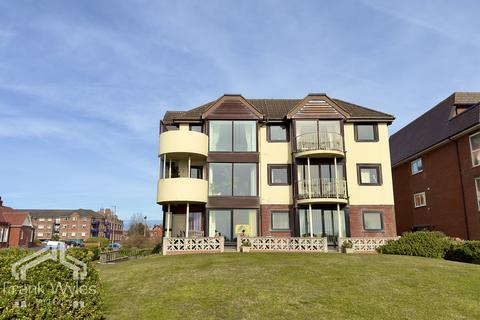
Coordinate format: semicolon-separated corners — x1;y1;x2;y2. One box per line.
157;178;208;203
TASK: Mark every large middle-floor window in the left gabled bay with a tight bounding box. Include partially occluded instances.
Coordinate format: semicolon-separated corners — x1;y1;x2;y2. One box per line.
208;163;257;196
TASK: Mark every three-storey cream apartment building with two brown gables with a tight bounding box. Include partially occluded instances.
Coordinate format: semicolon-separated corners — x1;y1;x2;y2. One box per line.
157;93;396;245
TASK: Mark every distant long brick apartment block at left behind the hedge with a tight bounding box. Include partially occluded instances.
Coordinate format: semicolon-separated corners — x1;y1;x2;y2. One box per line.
20;209;105;240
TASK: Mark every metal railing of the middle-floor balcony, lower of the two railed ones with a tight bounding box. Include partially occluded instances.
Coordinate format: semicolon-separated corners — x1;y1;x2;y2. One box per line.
297;178;347;199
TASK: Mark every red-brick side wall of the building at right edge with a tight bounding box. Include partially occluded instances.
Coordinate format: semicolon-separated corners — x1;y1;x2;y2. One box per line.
393;135;480;239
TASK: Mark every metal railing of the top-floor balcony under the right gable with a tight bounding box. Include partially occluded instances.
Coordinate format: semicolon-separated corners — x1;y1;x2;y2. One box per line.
296;132;344;152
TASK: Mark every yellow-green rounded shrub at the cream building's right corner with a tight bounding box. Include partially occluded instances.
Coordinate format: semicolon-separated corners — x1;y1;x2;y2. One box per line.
378;231;452;258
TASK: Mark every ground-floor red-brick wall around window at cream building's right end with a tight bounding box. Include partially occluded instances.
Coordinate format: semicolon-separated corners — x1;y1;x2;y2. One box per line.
348;205;397;237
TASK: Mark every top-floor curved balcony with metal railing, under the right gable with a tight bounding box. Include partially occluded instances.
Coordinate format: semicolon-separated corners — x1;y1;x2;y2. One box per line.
295;132;345;158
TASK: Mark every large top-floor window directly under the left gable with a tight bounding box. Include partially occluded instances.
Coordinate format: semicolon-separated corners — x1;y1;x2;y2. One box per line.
209;120;257;152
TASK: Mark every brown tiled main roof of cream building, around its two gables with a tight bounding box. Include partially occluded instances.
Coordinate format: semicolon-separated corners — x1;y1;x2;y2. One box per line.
163;94;395;124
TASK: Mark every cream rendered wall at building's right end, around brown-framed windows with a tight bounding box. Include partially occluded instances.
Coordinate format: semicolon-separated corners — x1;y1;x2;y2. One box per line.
344;123;394;205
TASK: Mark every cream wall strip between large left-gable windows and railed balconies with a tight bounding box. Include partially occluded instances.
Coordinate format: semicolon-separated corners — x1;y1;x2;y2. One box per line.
258;125;293;204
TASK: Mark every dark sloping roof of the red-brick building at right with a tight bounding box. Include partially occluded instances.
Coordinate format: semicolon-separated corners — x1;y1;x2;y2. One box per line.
390;92;480;165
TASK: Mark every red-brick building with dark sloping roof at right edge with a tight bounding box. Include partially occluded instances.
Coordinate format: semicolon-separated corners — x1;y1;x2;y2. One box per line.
390;92;480;240
